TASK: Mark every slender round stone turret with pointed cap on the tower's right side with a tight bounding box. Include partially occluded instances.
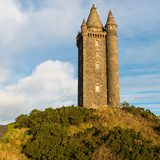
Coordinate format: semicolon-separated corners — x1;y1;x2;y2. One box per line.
105;10;120;107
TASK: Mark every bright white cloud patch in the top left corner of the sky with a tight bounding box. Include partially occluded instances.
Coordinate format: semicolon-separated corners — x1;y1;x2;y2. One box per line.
0;0;27;46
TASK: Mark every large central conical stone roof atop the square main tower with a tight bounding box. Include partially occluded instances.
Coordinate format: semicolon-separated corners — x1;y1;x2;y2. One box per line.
87;4;103;29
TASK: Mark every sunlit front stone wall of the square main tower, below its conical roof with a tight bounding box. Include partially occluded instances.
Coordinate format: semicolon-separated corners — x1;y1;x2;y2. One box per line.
83;32;107;108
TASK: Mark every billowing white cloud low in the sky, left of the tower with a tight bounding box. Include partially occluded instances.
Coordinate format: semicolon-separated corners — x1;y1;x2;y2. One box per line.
0;60;77;123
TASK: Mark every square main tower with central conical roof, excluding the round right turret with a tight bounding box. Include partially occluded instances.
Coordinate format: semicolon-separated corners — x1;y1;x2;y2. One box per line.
77;4;107;108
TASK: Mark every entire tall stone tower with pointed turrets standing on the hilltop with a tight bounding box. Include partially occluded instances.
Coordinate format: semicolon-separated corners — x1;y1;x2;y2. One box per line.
77;5;120;108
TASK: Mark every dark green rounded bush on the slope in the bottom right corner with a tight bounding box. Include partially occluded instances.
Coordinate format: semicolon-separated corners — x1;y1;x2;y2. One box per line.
106;127;159;160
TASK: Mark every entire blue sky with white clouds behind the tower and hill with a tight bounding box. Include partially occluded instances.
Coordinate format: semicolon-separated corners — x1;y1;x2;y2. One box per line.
0;0;160;124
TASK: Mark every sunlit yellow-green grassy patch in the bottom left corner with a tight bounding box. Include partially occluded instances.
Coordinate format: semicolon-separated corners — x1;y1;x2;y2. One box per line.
0;123;31;160
